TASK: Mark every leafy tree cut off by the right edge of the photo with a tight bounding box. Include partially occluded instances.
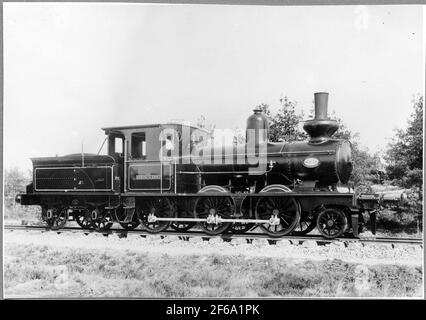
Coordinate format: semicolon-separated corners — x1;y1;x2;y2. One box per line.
385;96;423;190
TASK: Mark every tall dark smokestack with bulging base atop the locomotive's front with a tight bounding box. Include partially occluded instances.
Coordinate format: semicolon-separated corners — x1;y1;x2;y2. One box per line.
303;92;339;143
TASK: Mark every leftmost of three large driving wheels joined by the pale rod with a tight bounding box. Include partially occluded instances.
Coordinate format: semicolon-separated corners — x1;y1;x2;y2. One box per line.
136;197;174;233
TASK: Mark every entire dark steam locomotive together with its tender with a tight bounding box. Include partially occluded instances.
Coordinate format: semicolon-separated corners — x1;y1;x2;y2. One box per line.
16;92;379;239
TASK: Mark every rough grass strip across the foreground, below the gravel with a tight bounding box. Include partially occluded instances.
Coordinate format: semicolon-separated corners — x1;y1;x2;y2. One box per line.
4;244;423;298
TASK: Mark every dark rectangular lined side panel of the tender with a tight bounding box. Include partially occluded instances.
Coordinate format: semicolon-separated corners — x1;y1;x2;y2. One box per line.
34;166;113;191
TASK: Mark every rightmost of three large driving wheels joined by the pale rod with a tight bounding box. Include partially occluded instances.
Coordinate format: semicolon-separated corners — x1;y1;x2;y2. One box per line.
255;197;300;237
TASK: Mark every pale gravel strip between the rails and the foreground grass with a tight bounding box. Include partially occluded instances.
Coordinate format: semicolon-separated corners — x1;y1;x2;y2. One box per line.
4;230;423;266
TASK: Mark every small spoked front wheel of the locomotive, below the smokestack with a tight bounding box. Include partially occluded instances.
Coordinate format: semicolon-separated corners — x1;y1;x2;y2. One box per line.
317;208;348;239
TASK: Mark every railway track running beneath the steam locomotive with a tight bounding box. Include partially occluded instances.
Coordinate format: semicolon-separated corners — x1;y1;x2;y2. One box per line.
4;225;423;247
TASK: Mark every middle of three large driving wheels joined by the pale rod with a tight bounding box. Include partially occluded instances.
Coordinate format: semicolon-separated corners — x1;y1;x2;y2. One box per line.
194;196;234;235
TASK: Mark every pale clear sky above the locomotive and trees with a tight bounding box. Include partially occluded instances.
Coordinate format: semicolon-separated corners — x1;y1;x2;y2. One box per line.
3;3;425;169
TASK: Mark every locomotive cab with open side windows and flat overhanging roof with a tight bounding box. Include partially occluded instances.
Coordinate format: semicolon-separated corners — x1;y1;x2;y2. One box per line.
103;123;207;192
